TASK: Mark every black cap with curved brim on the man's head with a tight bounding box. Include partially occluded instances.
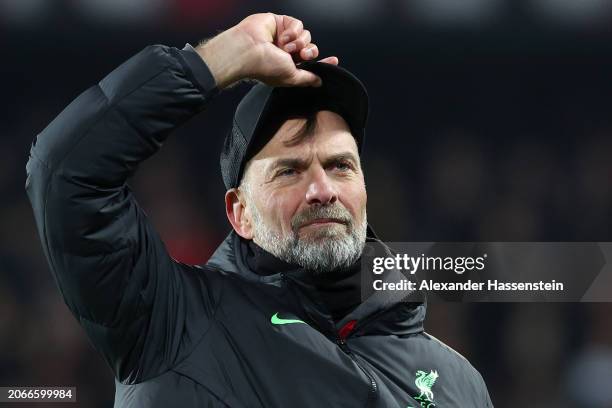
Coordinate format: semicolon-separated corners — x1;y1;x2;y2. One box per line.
221;61;368;190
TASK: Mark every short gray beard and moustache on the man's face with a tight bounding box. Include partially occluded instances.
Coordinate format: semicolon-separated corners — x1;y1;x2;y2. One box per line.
251;204;368;274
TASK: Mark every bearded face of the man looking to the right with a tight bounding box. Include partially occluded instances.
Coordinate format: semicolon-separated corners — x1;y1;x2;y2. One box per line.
241;111;367;272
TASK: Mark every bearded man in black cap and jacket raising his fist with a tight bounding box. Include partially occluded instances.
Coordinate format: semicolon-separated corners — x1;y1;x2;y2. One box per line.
26;13;491;408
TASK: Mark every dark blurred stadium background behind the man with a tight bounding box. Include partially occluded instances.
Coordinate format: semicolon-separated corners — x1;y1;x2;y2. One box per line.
0;0;612;408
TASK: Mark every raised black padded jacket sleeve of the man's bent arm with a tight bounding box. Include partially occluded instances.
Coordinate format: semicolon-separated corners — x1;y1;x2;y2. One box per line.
26;46;222;383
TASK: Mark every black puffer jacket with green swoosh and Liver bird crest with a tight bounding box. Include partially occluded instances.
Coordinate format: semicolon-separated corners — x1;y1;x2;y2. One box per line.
26;46;491;408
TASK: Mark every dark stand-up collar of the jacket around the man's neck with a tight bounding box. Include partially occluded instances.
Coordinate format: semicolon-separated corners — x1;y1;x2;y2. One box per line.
207;230;427;335
